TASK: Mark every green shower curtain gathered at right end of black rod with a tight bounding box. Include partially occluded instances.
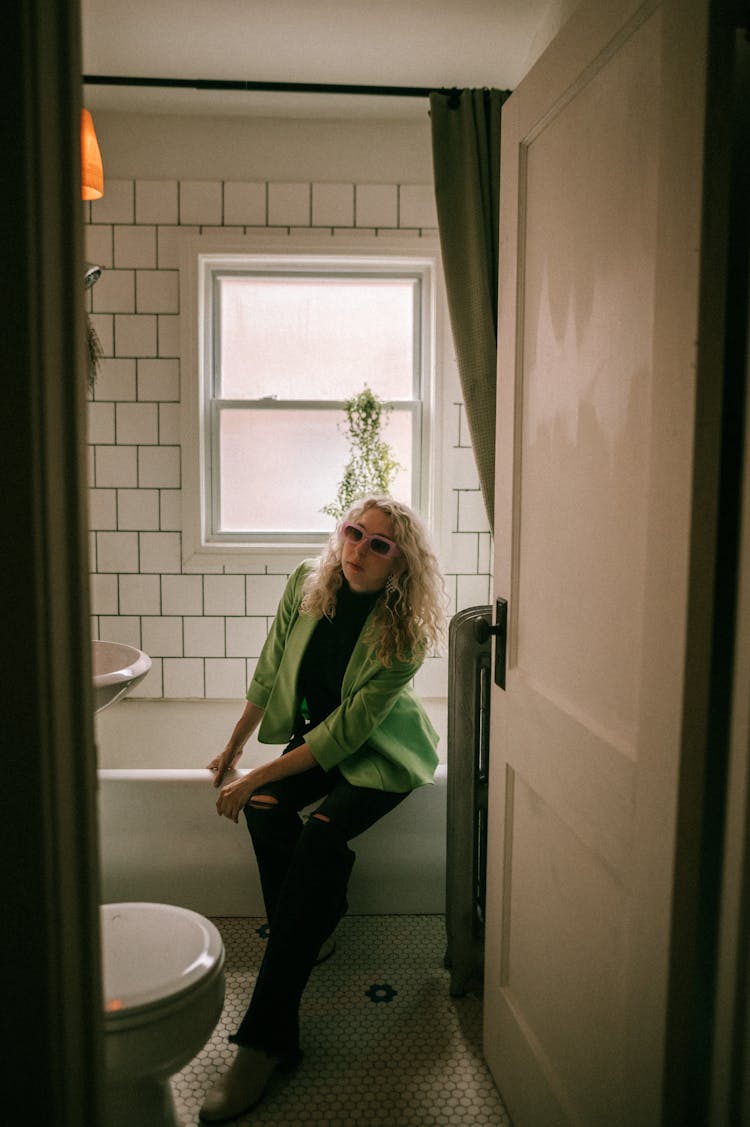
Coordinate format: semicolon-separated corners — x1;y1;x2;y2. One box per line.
430;90;510;530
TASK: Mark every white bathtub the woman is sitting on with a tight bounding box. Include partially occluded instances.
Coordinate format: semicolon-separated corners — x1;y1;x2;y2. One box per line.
97;701;447;916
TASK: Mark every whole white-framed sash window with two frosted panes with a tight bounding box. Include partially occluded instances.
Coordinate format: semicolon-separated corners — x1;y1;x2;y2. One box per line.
183;237;436;556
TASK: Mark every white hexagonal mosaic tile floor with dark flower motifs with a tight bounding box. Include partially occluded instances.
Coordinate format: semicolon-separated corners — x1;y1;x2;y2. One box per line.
173;915;511;1127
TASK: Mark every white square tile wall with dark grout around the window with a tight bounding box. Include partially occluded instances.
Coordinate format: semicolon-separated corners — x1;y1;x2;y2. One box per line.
83;179;492;700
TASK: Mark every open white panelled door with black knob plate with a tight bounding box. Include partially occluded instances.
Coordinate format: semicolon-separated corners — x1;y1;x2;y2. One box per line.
485;0;713;1127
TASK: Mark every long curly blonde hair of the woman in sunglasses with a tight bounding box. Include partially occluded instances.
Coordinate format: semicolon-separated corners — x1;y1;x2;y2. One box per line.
300;496;447;665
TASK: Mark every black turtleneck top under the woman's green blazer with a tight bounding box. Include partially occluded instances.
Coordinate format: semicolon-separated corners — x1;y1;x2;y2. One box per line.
297;579;380;725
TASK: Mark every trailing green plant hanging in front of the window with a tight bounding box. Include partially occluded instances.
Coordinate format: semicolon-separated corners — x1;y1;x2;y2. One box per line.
323;384;403;521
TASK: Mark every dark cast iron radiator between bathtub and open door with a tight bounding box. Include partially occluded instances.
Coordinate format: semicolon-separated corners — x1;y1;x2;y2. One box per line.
445;606;492;995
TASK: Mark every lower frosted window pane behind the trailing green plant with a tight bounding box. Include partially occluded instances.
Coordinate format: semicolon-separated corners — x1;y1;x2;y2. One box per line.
215;408;412;533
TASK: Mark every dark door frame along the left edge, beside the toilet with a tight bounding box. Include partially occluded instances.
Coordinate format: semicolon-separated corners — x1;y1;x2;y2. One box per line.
0;0;103;1127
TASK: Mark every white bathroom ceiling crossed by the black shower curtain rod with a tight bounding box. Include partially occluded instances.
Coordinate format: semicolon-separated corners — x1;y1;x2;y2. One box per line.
81;0;561;117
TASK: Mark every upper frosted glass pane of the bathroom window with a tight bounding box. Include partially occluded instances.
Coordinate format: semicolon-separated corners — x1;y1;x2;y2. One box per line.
218;274;418;400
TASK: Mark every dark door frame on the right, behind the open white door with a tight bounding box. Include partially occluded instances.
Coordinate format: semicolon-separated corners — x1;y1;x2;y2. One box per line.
681;10;750;1127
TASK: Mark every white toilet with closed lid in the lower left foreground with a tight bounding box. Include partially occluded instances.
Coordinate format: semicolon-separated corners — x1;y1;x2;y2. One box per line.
100;903;224;1127
